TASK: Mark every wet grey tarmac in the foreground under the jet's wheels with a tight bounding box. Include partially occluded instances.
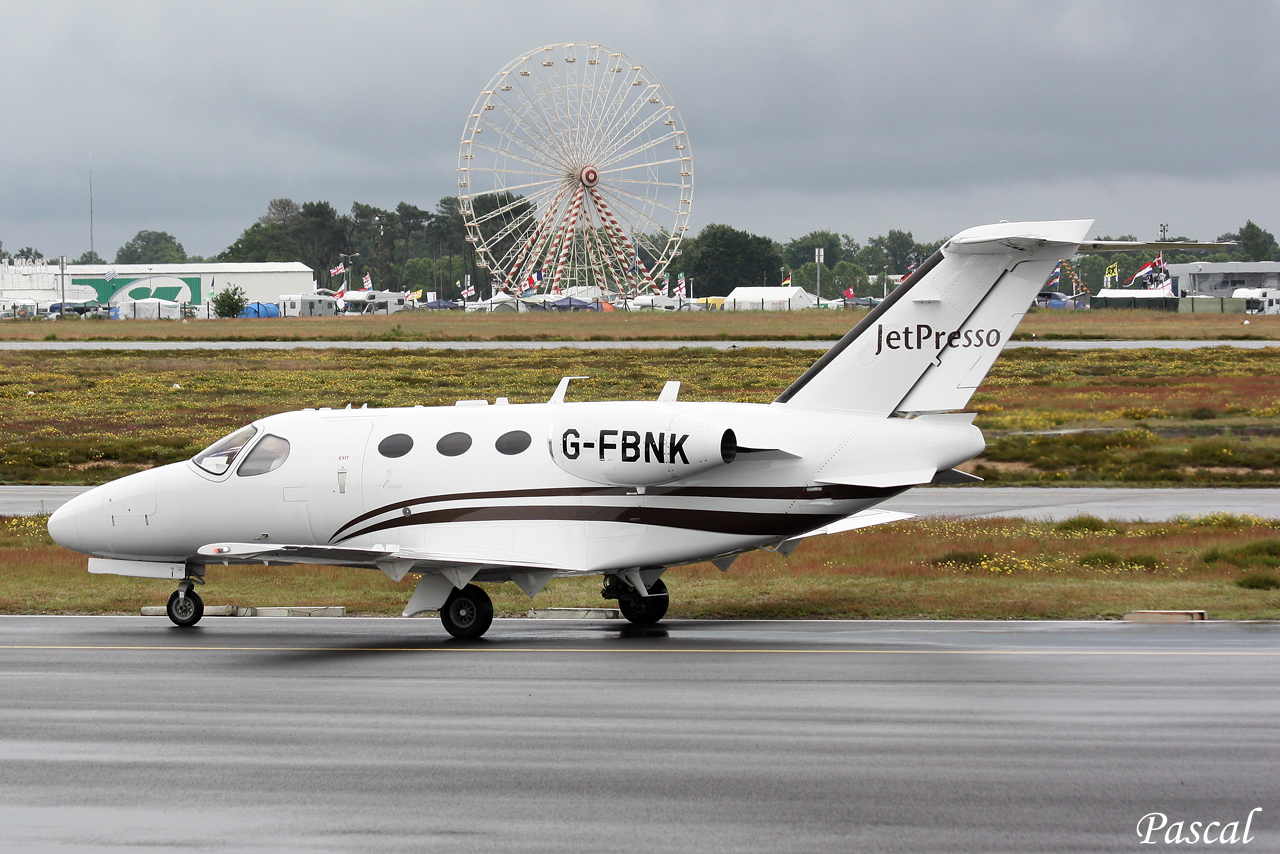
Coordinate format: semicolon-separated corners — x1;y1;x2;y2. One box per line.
0;617;1280;854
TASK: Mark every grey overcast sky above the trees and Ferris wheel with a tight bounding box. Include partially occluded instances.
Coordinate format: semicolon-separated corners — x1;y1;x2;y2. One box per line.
0;0;1280;259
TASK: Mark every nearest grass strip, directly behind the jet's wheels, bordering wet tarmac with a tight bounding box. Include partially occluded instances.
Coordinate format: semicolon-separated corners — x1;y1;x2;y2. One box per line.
0;516;1280;620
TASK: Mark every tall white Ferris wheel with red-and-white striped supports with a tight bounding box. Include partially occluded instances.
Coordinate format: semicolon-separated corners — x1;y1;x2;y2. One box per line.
458;44;694;298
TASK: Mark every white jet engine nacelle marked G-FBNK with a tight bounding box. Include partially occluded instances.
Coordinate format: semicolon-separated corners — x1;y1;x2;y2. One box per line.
550;403;737;487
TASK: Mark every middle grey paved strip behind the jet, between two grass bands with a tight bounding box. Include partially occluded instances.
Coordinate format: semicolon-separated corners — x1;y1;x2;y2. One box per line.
10;487;1280;522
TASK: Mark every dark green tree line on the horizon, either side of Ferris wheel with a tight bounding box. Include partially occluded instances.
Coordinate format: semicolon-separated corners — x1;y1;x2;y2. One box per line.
0;203;1280;300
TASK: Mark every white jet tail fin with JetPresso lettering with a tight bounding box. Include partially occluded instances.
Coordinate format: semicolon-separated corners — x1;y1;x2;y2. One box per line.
776;219;1093;417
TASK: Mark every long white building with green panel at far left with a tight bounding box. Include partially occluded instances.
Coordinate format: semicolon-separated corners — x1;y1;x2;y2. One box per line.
0;260;316;316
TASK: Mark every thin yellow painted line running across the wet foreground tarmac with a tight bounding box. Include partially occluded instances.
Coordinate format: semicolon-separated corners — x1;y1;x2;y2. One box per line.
0;644;1280;657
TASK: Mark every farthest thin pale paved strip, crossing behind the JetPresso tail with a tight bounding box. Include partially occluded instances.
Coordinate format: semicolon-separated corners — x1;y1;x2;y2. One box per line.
0;341;1280;352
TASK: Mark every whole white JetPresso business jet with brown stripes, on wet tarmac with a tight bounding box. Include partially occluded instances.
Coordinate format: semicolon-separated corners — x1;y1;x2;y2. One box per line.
49;220;1147;638
